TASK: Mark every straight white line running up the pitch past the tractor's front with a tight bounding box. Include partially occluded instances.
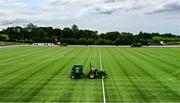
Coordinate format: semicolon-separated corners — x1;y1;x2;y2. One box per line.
99;48;106;103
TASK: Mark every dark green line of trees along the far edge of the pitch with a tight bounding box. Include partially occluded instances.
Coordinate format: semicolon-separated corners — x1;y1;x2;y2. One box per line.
0;23;180;45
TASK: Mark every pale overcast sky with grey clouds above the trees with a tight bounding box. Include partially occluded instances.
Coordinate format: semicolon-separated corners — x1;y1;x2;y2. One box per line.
0;0;180;34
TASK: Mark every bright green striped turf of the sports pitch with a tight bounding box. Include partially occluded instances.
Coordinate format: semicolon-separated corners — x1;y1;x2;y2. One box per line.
0;47;180;102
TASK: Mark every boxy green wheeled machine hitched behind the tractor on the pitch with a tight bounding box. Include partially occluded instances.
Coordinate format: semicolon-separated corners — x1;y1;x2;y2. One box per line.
70;65;84;79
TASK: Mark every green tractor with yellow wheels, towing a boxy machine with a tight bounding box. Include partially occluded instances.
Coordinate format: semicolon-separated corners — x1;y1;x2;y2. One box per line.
88;64;107;79
